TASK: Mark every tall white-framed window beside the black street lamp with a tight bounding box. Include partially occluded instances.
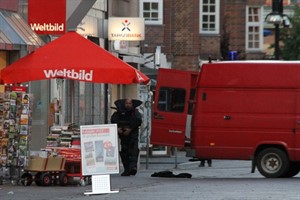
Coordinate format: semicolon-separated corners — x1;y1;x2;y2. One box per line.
246;7;263;50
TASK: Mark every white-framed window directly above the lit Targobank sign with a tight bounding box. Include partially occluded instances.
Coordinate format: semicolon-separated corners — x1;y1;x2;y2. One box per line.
140;0;163;24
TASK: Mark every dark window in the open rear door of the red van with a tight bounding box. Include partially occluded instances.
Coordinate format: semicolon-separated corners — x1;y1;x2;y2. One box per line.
158;87;186;112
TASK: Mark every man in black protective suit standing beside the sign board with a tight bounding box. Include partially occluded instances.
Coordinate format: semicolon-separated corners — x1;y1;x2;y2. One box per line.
111;99;142;176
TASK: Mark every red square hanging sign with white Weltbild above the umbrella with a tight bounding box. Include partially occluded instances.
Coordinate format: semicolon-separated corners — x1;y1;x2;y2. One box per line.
28;0;67;35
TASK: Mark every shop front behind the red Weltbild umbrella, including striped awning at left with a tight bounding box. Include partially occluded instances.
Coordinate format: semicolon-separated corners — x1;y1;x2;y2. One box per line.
0;0;150;156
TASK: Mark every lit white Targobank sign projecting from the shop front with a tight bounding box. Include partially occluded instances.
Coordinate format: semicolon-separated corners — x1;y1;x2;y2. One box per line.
108;17;145;41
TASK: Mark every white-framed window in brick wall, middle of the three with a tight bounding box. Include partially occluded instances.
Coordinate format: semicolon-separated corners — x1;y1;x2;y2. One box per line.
199;0;220;34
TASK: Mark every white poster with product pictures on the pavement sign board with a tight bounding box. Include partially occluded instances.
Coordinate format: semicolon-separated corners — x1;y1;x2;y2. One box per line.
80;124;119;176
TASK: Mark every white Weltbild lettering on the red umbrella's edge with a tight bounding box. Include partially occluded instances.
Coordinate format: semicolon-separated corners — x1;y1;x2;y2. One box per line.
44;69;93;81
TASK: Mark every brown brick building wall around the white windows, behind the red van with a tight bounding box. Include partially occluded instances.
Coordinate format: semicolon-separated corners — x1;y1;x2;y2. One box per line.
142;0;265;70
